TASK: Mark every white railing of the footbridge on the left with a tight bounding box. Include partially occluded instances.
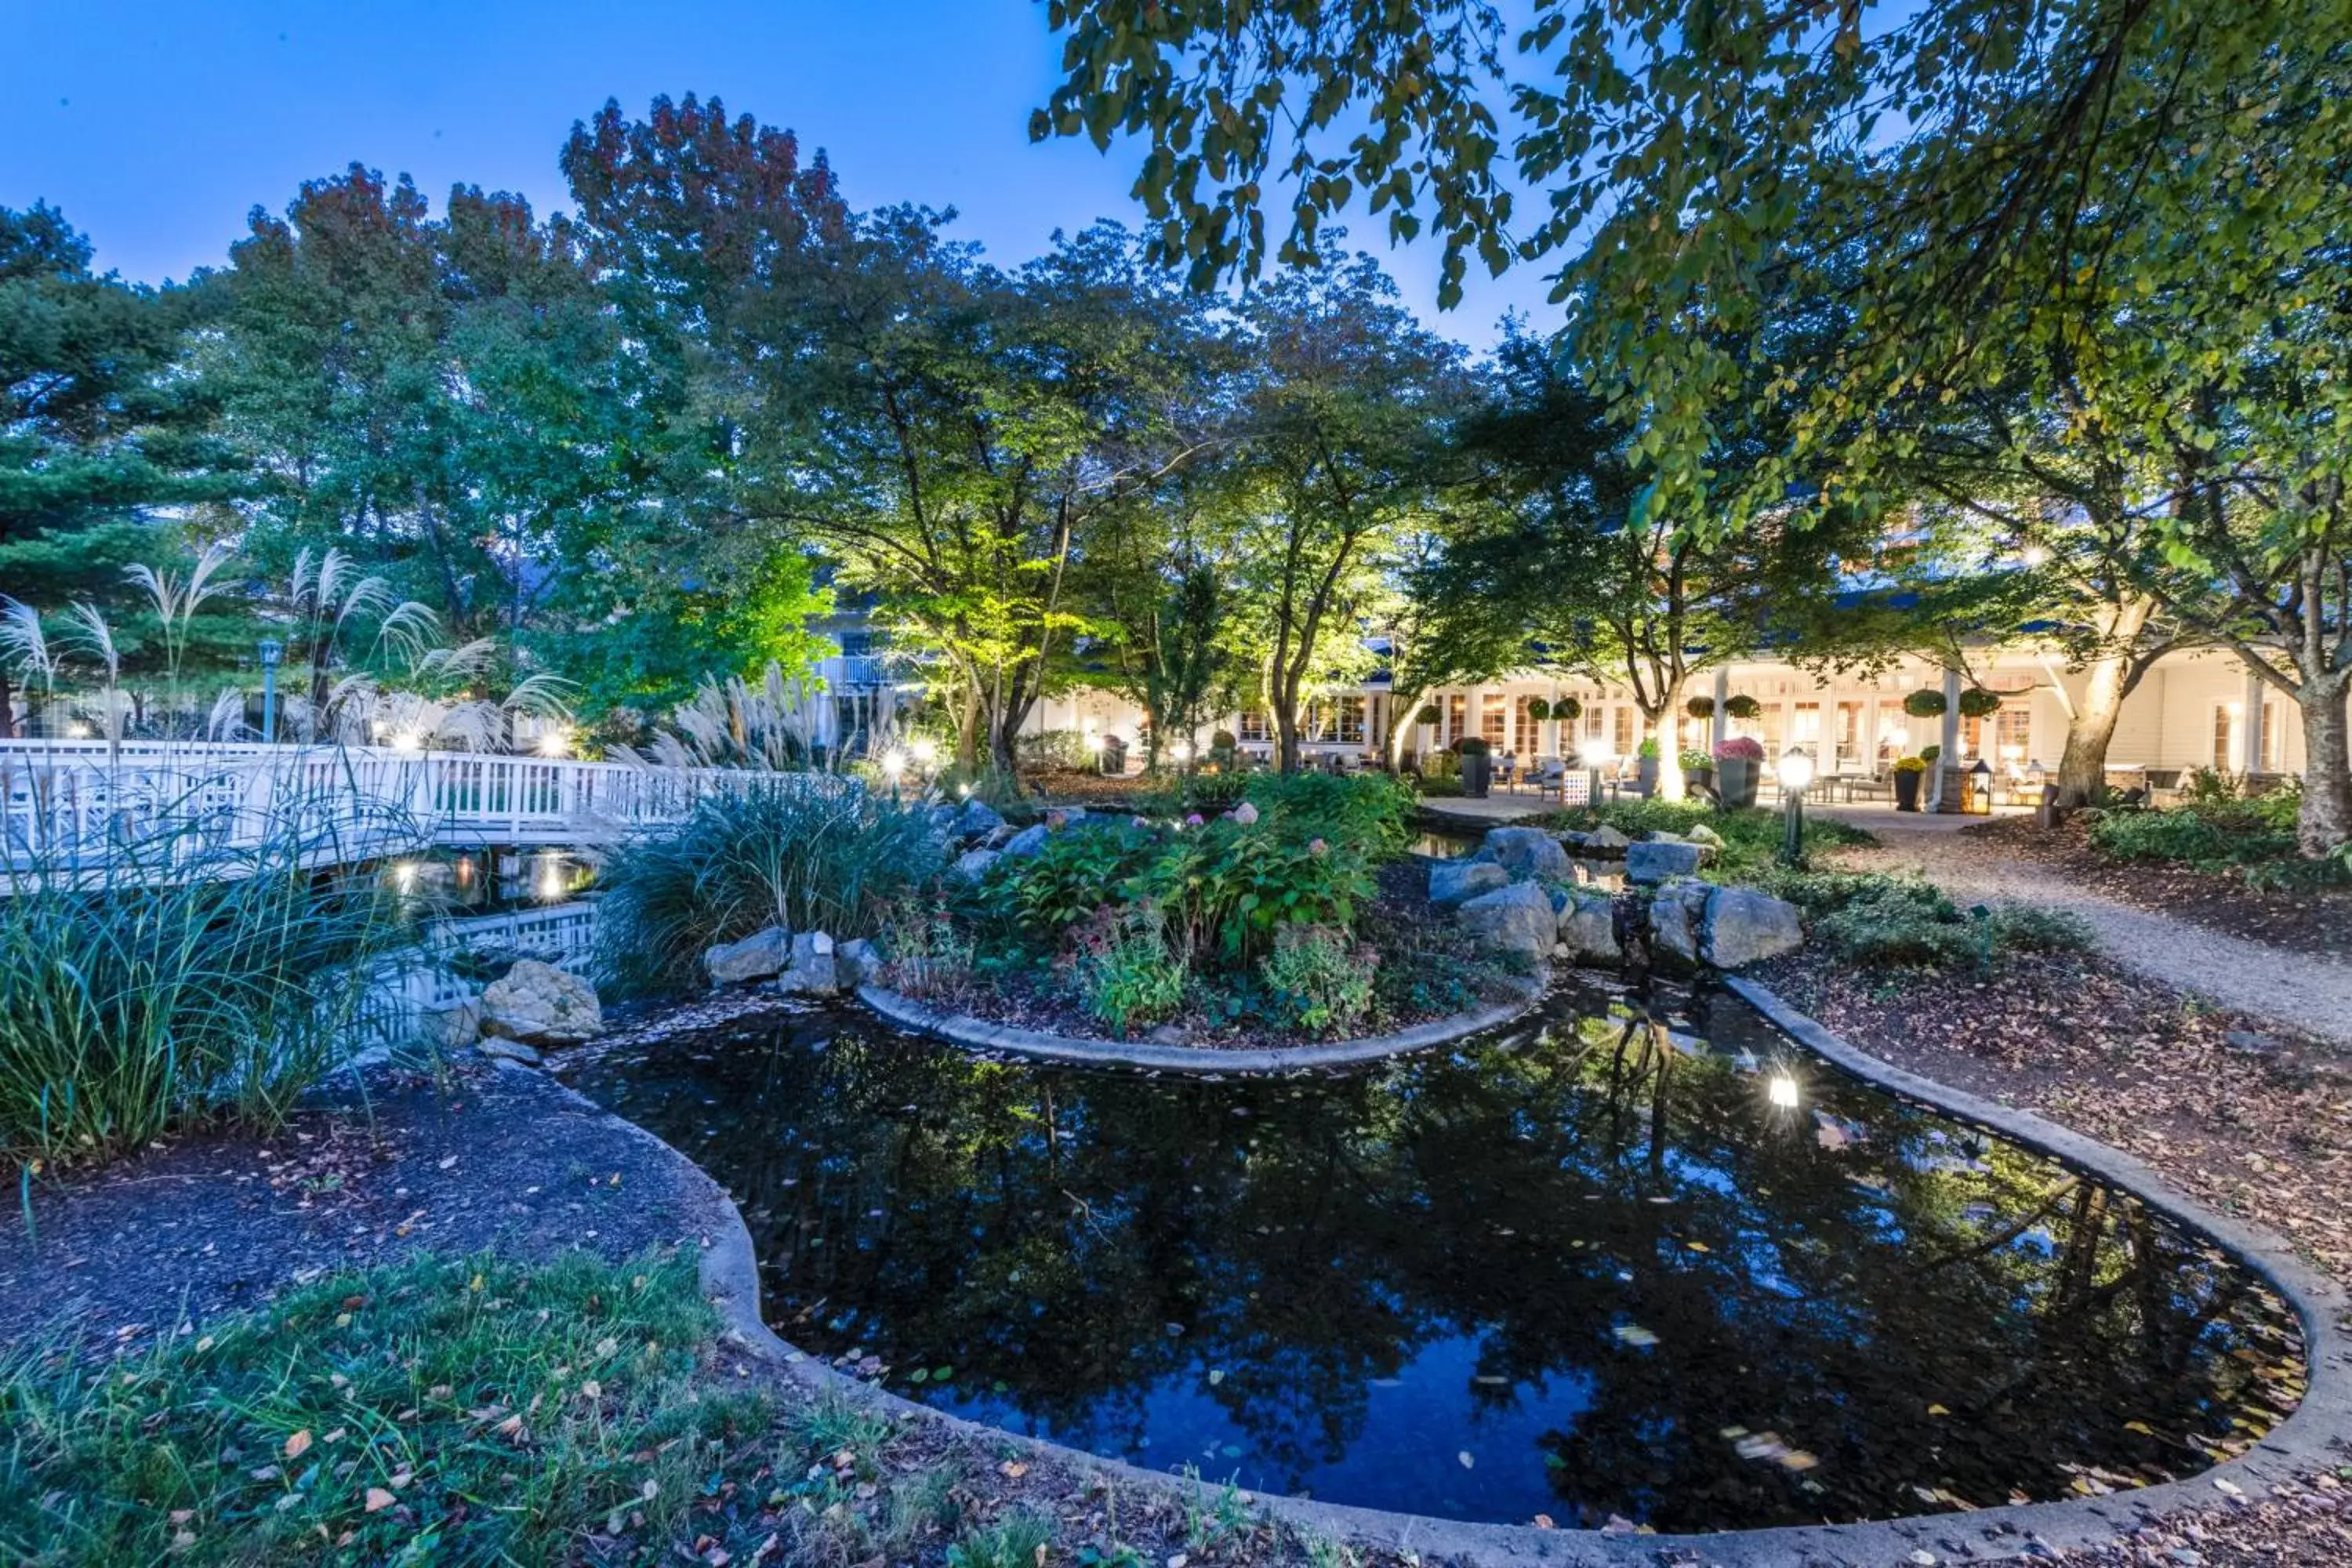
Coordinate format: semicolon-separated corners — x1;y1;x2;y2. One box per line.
0;741;842;865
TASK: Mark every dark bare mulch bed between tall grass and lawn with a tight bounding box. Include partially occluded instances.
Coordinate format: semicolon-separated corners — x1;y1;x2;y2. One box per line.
0;1065;713;1349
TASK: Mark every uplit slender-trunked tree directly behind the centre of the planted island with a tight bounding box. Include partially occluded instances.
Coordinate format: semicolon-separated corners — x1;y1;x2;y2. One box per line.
1228;254;1470;774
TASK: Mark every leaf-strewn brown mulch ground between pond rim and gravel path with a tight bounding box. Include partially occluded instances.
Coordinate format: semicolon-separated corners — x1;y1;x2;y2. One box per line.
1757;954;2352;1568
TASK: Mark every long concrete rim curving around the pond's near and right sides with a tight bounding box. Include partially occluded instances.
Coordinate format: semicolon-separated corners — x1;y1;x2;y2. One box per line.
574;975;2352;1568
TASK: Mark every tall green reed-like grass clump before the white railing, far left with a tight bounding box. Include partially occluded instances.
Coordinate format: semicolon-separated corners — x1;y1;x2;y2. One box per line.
0;806;405;1163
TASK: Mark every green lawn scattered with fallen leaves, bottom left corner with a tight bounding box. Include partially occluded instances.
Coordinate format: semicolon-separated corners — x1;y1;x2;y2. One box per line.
0;1253;769;1568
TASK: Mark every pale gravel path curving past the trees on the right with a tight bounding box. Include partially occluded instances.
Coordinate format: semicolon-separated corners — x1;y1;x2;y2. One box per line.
1837;822;2352;1046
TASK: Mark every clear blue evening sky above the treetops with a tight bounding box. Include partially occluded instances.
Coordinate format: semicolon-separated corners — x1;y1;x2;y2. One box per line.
13;0;1557;343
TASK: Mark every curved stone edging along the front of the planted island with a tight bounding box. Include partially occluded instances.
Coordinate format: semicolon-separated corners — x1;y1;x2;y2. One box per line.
856;968;1550;1074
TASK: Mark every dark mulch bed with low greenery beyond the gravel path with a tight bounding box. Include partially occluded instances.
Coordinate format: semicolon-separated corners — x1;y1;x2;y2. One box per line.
1959;815;2352;959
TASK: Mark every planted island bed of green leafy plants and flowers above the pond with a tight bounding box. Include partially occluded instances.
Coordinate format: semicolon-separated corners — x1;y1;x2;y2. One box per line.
880;776;1522;1046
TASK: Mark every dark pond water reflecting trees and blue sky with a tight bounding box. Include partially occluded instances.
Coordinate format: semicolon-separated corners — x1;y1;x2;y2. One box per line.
564;989;2300;1530
